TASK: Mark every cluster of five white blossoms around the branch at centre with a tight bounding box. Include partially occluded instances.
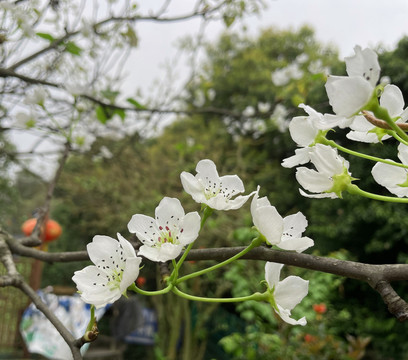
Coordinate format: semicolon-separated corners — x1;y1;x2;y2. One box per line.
73;159;313;325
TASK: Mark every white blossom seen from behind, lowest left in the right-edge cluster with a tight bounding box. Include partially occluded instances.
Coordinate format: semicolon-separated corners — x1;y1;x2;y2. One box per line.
296;144;352;199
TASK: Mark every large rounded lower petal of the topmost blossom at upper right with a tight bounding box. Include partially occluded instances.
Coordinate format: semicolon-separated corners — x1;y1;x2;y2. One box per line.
325;76;374;117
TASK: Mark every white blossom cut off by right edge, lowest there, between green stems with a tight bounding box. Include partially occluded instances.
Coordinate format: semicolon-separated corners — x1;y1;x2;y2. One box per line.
371;144;408;197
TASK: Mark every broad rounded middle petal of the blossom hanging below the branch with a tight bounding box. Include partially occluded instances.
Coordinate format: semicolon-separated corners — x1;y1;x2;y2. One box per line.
274;276;309;310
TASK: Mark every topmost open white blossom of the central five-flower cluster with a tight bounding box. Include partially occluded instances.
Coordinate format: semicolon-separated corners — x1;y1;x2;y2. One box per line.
180;159;253;210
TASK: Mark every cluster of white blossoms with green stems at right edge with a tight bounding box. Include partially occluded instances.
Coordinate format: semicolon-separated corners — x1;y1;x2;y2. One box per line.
282;46;408;200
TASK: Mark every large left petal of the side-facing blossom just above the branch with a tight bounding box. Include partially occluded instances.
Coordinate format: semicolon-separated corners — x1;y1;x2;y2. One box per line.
252;206;283;245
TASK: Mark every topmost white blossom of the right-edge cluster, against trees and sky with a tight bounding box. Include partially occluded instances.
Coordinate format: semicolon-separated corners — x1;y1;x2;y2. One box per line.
325;46;381;117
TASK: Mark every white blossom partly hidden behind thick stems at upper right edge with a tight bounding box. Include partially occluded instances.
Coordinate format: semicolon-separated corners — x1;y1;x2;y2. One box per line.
346;85;408;143
